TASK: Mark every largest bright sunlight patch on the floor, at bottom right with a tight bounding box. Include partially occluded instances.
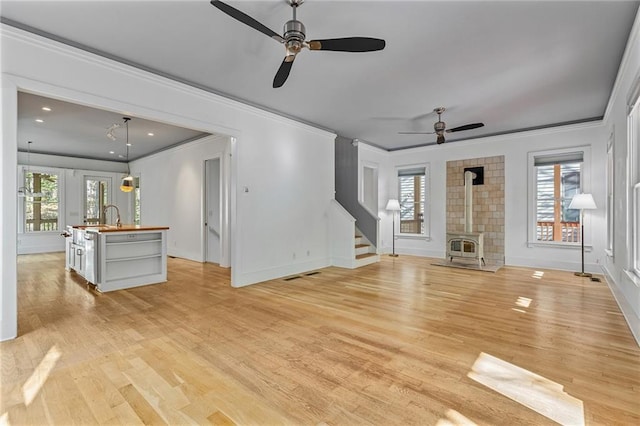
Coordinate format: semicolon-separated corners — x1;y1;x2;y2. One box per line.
467;352;584;426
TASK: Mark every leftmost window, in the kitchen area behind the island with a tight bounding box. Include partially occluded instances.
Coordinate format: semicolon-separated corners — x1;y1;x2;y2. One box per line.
23;170;60;233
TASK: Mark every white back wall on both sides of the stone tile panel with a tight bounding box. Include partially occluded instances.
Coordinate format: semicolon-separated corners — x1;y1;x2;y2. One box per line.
372;122;606;272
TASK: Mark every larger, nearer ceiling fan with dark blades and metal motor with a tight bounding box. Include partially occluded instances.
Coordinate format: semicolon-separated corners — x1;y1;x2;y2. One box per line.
211;0;385;88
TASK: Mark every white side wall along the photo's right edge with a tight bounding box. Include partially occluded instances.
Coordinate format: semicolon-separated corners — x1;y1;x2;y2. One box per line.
603;14;640;343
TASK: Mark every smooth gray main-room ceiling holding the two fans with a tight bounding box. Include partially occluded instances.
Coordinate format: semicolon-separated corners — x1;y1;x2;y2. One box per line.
0;0;639;158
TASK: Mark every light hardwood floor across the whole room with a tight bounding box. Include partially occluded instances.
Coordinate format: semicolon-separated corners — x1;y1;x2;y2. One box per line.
0;253;640;425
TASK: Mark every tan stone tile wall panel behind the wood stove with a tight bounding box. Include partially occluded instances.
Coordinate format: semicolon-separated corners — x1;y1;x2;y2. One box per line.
447;155;504;265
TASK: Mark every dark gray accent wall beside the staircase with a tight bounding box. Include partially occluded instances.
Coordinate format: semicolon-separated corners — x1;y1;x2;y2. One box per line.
335;136;378;245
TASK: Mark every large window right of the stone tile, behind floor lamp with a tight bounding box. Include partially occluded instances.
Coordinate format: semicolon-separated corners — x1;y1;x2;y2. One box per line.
529;148;587;244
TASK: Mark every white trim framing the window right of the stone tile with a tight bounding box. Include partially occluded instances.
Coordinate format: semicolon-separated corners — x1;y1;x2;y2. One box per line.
527;145;593;248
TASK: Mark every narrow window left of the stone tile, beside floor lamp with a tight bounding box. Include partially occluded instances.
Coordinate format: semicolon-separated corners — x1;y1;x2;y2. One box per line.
398;166;428;236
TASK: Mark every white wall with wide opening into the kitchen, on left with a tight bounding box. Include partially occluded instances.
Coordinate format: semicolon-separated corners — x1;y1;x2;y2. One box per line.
0;25;335;340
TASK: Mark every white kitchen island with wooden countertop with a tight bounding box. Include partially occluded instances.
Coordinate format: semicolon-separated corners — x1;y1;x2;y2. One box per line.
66;225;169;292
